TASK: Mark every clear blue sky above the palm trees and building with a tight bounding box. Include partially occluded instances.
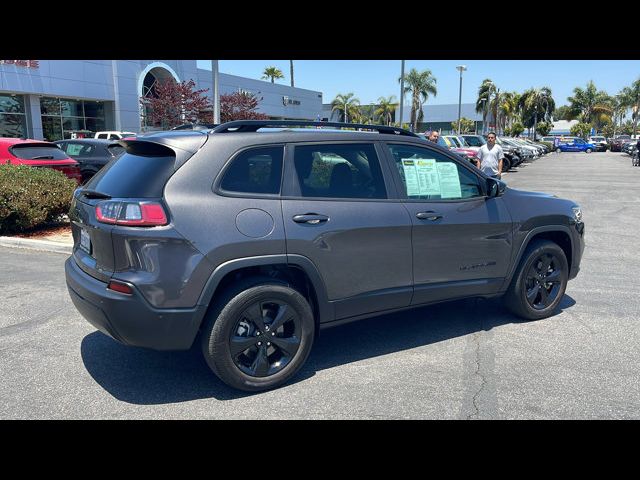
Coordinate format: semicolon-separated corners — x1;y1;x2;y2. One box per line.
198;60;640;106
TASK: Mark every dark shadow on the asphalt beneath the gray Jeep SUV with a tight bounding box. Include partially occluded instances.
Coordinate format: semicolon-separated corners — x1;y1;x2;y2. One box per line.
80;294;575;405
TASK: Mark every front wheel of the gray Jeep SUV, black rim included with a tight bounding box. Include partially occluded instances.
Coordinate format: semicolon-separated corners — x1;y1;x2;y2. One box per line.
504;240;569;320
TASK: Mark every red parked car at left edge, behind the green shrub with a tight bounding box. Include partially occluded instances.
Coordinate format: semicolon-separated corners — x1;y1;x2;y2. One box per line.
0;138;82;185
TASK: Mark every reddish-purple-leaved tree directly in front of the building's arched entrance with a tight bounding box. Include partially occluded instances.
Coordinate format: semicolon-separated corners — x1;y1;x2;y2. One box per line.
140;79;212;130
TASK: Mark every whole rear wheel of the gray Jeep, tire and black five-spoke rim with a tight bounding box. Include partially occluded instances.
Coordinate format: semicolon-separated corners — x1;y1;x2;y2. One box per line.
202;283;315;392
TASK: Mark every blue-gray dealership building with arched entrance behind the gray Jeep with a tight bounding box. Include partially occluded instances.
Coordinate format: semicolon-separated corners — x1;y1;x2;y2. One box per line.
0;60;322;141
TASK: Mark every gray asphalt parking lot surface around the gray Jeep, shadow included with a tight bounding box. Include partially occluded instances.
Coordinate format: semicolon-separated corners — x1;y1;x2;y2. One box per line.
0;153;640;419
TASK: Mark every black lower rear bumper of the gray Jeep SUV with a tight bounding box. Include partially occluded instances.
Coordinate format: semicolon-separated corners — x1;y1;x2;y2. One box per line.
65;257;207;350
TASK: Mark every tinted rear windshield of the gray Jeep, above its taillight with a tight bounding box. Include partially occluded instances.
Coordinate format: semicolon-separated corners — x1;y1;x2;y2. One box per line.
86;146;176;198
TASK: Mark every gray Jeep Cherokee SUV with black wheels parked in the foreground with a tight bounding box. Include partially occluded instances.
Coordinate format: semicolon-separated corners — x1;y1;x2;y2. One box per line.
65;121;584;391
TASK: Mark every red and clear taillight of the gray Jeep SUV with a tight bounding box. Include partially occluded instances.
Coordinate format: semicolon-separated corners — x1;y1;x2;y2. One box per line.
96;200;168;227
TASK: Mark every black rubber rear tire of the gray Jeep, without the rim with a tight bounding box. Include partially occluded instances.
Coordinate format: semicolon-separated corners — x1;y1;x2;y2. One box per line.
203;285;315;391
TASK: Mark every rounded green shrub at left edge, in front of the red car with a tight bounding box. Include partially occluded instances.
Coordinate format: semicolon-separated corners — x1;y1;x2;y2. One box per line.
0;165;77;234
